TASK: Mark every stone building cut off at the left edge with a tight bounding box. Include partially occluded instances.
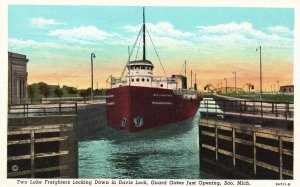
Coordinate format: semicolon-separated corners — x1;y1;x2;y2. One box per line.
8;52;29;104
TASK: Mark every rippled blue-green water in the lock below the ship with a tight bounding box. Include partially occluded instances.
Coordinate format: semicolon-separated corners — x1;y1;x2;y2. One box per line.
78;112;215;179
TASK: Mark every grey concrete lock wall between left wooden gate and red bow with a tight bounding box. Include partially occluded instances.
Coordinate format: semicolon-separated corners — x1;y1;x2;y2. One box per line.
77;103;107;138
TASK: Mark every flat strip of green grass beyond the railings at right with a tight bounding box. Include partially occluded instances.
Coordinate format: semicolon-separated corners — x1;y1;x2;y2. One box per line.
220;93;294;102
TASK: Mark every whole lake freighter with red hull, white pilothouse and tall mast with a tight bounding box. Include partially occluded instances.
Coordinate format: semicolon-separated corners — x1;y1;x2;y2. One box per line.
106;9;202;132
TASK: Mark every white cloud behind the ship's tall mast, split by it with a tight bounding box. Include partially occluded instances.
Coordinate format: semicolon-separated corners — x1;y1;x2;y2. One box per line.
124;22;195;37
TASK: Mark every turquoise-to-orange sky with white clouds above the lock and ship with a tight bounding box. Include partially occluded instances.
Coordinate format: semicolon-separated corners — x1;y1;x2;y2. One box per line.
8;5;294;91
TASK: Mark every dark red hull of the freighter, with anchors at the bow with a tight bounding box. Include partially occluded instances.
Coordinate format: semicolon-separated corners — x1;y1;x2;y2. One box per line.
106;86;201;132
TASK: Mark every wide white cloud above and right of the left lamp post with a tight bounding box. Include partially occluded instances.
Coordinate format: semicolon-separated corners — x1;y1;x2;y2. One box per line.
49;25;117;44
